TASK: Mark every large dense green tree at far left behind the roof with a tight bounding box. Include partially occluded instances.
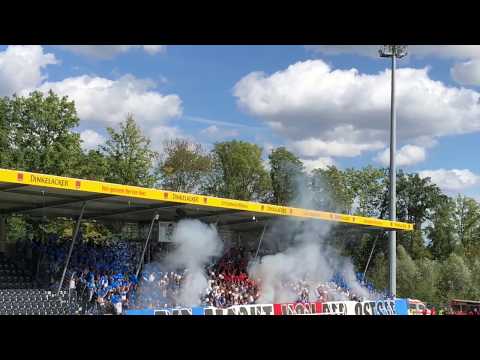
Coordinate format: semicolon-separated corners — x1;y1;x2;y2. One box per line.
0;91;81;176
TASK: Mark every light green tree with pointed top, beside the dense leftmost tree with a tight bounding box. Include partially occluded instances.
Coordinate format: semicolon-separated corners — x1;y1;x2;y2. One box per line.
100;115;158;187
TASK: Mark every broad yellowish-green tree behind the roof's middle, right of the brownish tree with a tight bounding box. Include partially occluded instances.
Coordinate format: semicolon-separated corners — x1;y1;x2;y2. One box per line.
205;140;270;201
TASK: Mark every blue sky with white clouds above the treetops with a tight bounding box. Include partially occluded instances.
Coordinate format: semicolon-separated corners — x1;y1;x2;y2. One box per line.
0;45;480;200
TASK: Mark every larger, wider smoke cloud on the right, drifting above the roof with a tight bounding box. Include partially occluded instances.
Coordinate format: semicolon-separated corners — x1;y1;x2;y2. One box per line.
248;172;374;303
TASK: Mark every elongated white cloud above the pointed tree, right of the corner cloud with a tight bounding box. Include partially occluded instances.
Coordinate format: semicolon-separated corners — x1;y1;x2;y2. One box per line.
38;75;182;129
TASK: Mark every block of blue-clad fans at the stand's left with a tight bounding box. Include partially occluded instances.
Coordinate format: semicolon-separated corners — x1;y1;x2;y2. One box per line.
33;236;139;314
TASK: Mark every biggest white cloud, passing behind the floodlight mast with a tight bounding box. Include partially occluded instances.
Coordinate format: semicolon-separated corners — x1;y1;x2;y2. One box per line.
234;60;480;157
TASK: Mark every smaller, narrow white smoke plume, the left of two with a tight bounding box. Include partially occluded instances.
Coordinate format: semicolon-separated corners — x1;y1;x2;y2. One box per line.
165;219;223;306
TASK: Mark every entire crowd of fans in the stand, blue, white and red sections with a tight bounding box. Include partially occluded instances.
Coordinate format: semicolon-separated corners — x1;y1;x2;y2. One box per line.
24;238;388;314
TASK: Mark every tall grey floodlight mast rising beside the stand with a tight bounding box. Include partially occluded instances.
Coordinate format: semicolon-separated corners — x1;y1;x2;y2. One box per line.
379;45;408;298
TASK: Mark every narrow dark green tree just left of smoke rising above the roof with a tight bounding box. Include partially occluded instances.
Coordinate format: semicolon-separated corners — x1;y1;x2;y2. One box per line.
268;146;304;205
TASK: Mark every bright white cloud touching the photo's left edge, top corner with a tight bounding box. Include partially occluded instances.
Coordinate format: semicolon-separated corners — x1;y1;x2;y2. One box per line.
0;45;59;96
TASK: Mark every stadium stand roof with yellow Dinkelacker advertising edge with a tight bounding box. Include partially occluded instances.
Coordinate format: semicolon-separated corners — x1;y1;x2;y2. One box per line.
0;169;413;231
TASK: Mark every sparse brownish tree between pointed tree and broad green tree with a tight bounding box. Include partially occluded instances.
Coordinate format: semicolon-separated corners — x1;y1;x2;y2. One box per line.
158;139;212;192
